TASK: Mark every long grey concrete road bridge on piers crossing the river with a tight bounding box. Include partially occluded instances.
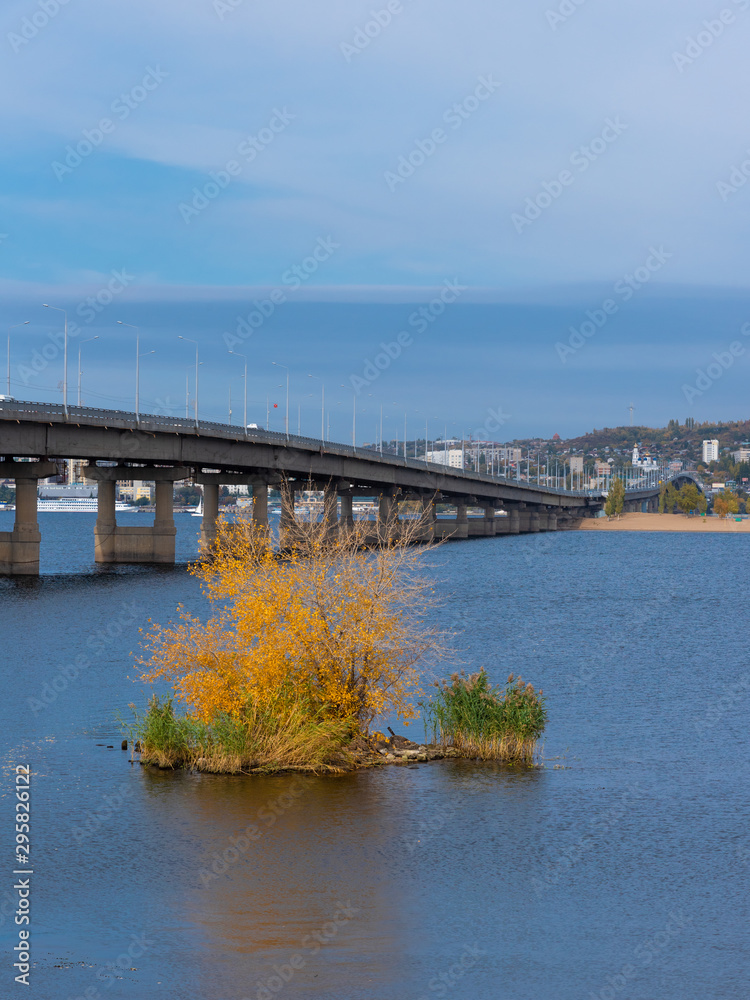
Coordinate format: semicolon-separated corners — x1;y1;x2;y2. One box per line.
0;400;694;575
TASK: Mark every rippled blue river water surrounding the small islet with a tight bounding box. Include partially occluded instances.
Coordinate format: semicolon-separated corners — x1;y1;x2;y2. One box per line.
0;512;750;1000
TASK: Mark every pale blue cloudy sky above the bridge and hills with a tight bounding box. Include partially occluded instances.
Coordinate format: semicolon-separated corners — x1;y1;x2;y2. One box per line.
0;0;750;439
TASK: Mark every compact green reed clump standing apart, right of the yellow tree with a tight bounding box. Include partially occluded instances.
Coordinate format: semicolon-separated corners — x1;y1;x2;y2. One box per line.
423;670;547;764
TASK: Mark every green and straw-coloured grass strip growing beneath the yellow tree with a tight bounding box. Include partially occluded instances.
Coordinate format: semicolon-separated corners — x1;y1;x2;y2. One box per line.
127;697;353;774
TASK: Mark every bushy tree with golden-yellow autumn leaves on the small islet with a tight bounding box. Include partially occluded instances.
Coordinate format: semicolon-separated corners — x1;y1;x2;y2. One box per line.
140;519;440;730
